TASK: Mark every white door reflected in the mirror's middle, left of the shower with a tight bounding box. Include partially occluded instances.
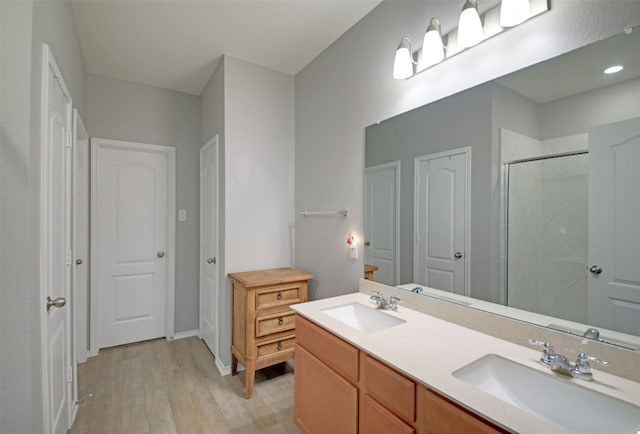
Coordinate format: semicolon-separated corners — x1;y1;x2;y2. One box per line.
414;148;471;295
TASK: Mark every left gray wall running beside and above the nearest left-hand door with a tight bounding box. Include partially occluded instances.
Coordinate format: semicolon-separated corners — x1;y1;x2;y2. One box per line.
0;0;85;434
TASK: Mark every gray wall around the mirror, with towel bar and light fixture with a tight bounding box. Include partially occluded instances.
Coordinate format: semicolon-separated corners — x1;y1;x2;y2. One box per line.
295;0;640;298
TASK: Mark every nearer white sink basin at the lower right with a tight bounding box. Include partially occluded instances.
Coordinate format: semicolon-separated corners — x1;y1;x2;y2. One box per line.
453;354;640;434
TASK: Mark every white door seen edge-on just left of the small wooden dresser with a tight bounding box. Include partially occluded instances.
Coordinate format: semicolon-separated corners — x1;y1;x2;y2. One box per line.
200;135;219;356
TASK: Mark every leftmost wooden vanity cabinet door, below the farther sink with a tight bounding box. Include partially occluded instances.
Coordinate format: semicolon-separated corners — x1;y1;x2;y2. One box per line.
294;345;358;434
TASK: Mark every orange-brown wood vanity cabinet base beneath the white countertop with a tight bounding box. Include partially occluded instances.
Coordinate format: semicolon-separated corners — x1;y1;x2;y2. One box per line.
294;316;505;434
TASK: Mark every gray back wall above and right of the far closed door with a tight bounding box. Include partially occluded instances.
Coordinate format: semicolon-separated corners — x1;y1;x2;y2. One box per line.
86;74;200;333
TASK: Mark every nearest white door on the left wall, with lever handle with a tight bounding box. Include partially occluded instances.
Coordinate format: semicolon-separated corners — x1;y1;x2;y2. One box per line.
40;45;72;434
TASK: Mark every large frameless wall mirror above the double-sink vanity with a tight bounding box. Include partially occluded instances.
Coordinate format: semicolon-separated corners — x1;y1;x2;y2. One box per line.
364;29;640;349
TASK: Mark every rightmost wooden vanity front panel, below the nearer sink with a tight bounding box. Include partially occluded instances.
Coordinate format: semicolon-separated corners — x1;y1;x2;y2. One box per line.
417;385;507;434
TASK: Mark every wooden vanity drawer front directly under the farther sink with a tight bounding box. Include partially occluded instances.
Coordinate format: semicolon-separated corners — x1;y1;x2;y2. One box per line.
296;315;358;383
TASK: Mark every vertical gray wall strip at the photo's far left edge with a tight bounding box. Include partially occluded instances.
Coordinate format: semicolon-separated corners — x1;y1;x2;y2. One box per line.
0;1;36;433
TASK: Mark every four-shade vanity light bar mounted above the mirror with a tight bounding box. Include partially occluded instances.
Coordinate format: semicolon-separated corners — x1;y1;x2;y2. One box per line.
393;0;552;79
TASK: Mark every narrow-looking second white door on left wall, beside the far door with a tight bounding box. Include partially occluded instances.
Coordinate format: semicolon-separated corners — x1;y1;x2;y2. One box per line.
72;109;91;366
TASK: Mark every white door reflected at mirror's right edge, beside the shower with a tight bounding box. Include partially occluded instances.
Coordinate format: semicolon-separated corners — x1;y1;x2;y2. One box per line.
588;118;640;335
